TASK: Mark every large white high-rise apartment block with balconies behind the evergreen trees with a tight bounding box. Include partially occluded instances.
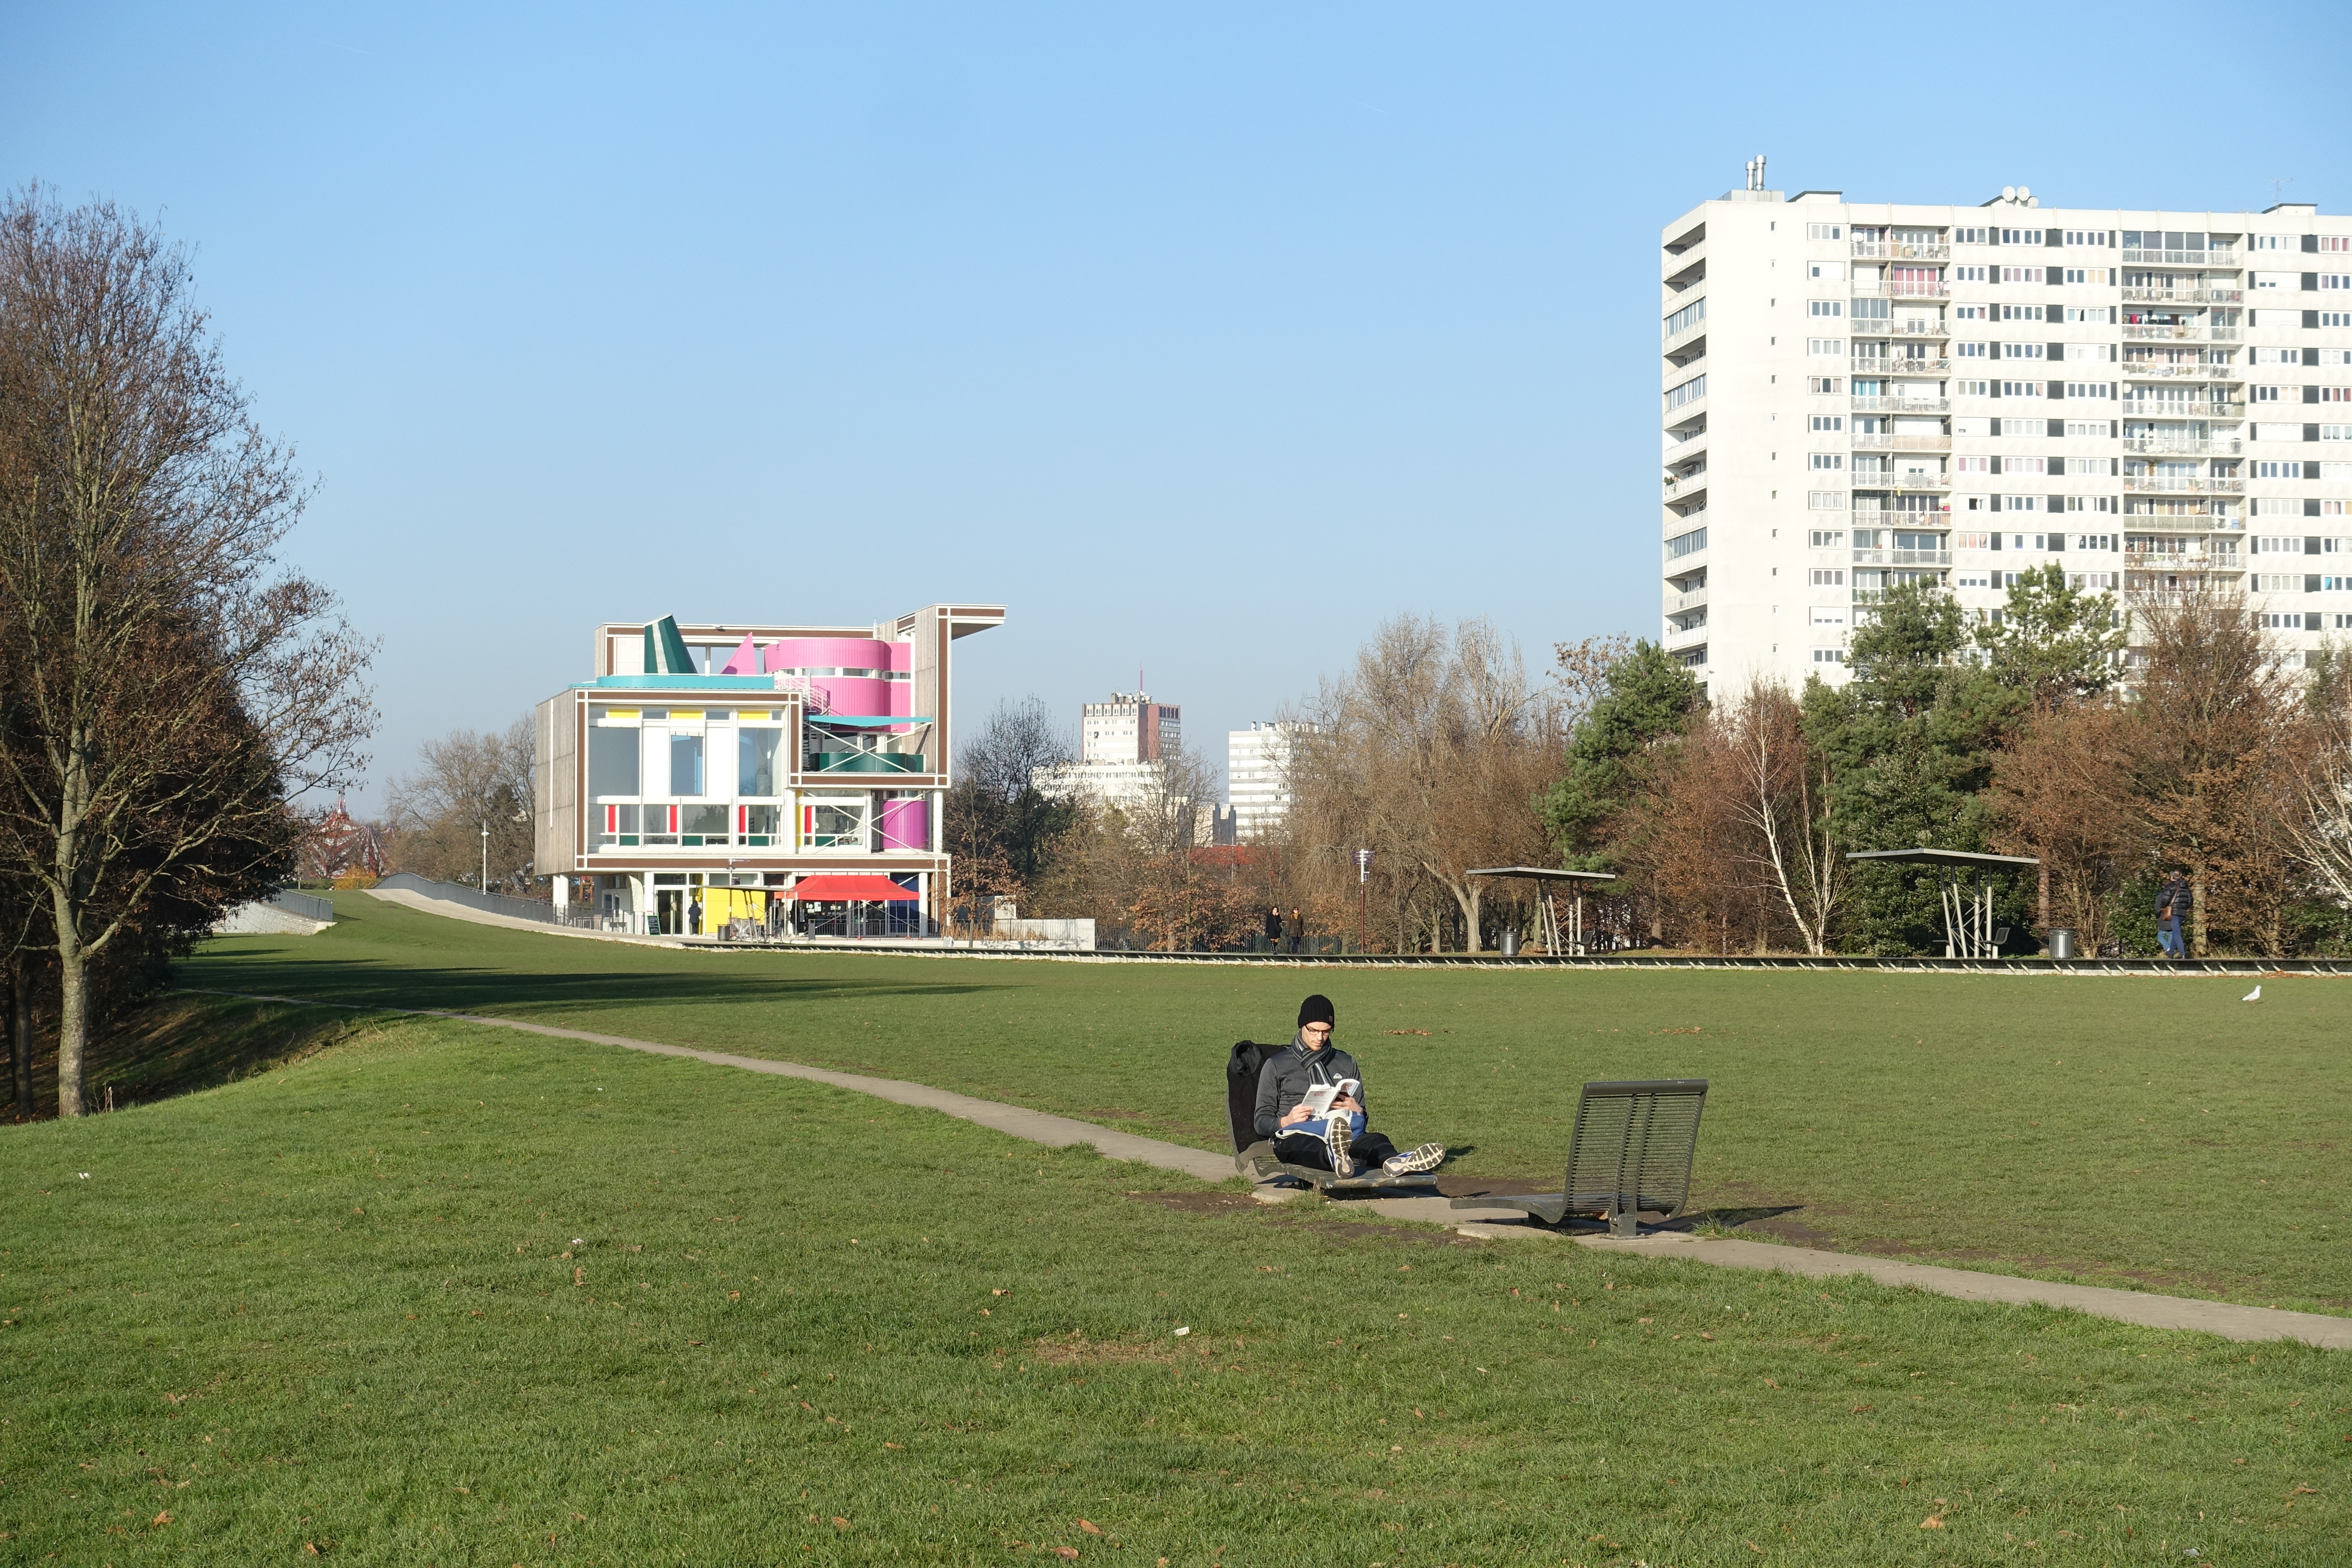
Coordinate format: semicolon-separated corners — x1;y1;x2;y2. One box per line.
1660;172;2352;693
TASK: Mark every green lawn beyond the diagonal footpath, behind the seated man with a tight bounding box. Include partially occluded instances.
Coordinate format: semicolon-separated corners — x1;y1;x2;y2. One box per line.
181;893;2352;1312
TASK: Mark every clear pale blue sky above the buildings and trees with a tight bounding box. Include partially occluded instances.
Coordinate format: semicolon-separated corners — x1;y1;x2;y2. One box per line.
0;2;2352;804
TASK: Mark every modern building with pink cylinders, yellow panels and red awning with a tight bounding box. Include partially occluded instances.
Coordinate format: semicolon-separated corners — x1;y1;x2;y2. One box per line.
534;604;1004;938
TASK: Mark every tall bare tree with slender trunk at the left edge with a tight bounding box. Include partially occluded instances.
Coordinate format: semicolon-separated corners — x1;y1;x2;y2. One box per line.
0;188;374;1117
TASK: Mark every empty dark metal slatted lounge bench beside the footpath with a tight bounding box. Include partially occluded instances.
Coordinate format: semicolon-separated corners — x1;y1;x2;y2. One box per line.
1454;1079;1708;1237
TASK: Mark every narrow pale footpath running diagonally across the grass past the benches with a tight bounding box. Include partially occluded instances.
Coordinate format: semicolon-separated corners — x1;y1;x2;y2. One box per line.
195;987;2352;1349
